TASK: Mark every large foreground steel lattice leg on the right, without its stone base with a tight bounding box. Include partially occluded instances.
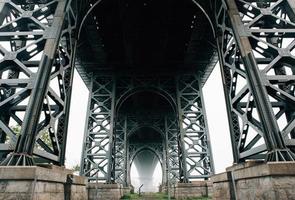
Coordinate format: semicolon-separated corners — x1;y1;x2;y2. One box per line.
215;0;295;162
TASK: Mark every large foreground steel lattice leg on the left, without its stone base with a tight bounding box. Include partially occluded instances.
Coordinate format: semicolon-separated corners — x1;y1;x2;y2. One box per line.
0;0;76;165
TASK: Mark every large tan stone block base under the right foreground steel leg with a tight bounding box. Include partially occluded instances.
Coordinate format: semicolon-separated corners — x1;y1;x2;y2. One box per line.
211;162;295;200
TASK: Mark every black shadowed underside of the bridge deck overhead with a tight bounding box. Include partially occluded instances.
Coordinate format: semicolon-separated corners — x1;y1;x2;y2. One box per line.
76;0;218;85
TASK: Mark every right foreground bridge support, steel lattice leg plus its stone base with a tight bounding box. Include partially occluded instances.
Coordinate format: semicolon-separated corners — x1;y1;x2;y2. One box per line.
212;0;295;199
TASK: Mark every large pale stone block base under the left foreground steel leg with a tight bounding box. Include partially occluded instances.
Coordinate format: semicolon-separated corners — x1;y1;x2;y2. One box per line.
0;166;87;200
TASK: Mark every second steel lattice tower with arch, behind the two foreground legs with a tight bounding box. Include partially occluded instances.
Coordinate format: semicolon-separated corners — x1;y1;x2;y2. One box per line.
82;75;214;185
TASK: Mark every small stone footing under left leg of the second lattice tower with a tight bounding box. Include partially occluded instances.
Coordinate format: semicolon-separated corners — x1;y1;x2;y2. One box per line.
87;183;124;200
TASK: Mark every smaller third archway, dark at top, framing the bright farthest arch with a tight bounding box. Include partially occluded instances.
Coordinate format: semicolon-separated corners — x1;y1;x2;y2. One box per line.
128;127;165;192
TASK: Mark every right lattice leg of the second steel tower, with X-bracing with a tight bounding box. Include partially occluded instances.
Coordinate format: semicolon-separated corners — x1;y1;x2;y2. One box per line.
177;75;214;182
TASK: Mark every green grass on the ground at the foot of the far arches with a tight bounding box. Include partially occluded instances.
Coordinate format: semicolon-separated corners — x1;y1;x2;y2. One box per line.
121;193;211;200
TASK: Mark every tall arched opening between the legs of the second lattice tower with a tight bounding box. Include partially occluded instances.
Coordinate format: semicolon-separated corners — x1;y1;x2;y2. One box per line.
117;89;170;189
